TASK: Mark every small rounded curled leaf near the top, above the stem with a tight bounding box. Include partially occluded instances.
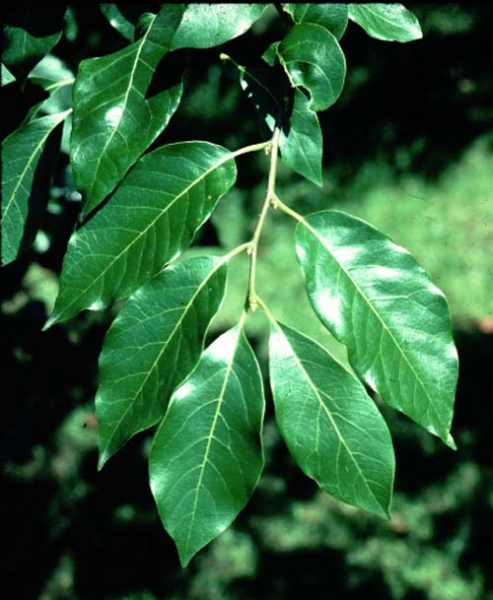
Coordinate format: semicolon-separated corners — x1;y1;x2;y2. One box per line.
277;23;346;111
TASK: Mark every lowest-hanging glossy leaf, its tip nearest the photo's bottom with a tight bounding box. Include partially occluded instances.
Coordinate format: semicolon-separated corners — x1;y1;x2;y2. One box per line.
150;326;264;566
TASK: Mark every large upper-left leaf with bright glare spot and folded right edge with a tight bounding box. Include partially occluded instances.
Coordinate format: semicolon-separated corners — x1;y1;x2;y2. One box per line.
71;4;184;215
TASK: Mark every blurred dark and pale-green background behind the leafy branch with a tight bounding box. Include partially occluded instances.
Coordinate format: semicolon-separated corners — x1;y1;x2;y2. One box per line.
0;2;493;600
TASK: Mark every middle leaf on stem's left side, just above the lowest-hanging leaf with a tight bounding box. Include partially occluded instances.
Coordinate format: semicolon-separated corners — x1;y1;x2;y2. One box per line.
96;257;227;468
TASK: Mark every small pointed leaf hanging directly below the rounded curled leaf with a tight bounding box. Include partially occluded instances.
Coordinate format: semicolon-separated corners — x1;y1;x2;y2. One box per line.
279;89;323;186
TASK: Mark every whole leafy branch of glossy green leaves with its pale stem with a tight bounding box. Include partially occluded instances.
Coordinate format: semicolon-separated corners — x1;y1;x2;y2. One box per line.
1;3;457;565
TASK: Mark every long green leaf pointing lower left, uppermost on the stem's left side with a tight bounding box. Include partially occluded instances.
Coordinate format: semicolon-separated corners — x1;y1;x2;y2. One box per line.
45;142;236;328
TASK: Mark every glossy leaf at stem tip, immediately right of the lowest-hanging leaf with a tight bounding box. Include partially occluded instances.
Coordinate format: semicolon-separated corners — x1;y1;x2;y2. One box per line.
269;323;395;517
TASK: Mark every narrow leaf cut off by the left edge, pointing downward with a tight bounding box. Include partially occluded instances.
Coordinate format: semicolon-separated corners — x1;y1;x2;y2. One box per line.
2;111;70;265
